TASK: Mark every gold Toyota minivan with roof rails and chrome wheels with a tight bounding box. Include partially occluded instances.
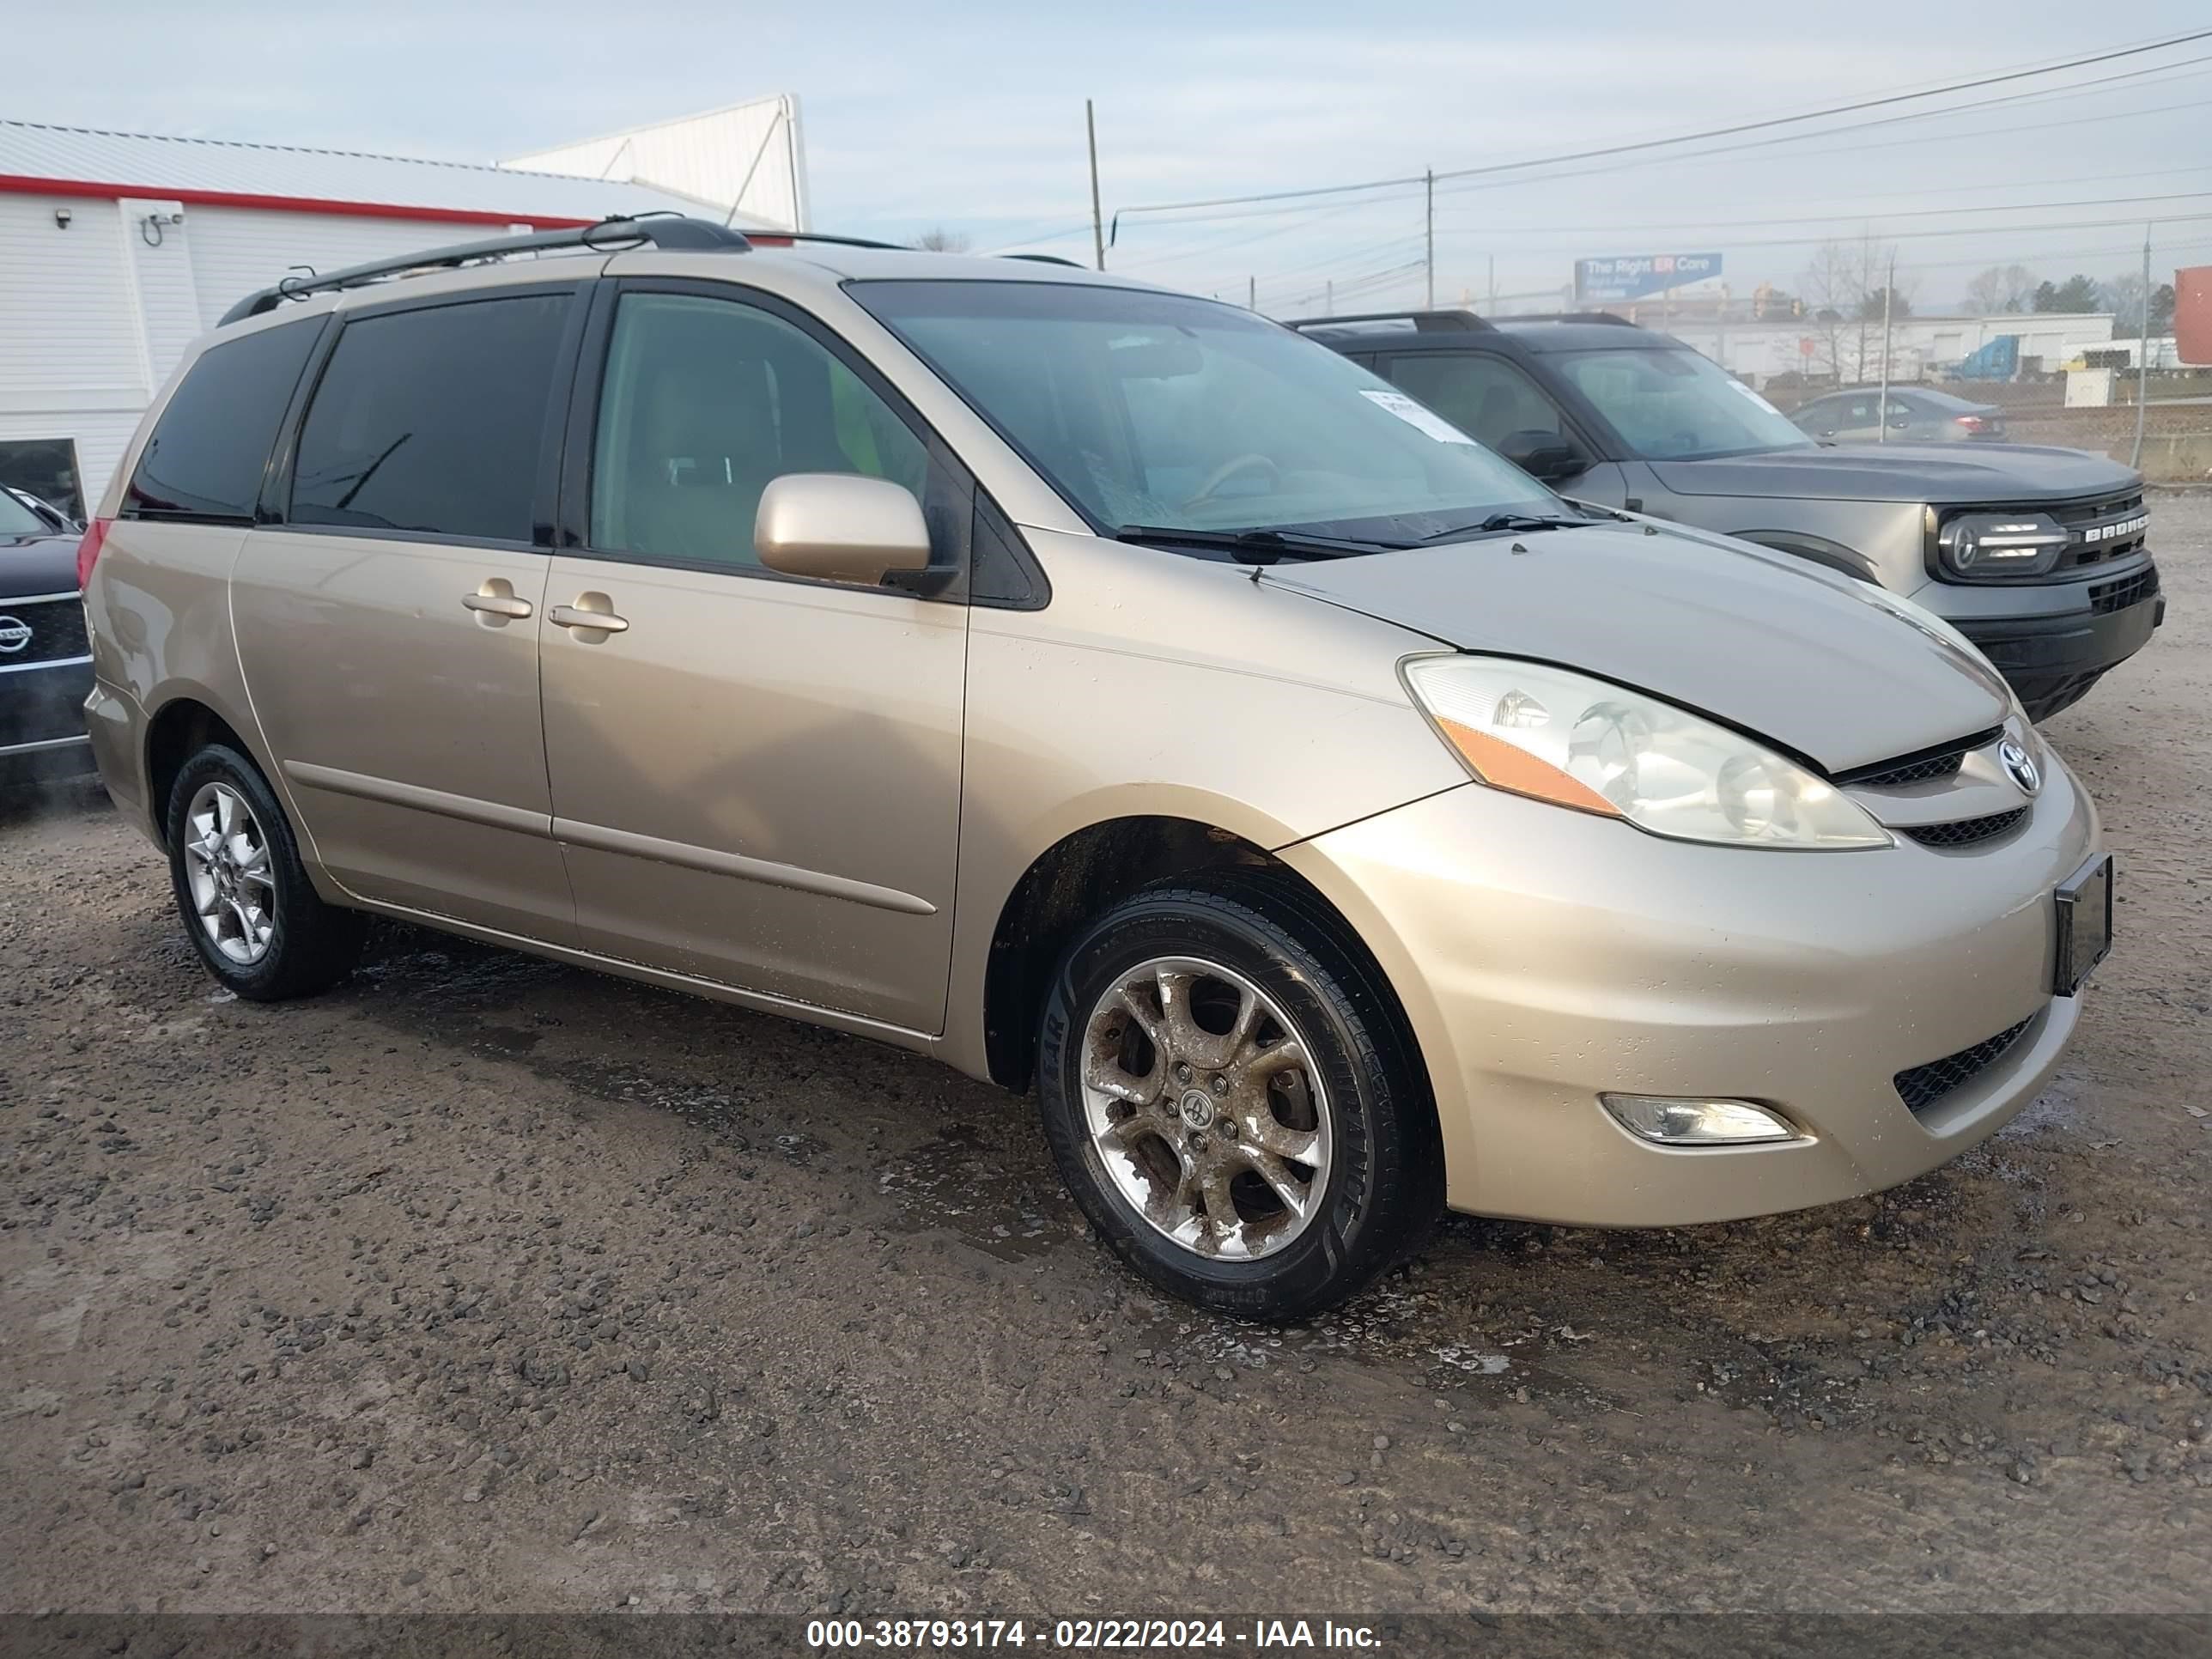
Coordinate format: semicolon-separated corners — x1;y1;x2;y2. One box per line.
80;219;2112;1318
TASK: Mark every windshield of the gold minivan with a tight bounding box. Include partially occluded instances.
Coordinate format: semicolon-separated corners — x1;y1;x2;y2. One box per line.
848;281;1573;550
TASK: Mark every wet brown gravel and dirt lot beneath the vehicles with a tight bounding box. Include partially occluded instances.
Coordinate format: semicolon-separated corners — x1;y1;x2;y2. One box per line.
0;495;2212;1614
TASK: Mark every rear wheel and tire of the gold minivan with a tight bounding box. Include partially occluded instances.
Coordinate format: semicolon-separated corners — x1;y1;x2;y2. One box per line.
168;744;368;1002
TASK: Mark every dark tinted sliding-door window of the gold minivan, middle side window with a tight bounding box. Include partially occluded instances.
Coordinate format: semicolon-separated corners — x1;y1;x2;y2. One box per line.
292;295;568;542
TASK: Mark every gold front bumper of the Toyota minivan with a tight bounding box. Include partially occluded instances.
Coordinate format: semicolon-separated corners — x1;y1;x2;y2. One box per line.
1281;757;2100;1225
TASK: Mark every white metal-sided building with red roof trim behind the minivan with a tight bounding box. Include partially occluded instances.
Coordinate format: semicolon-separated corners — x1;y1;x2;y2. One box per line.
0;111;805;515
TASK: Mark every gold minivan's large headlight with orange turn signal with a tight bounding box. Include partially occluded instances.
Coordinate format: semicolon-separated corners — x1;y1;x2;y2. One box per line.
1405;657;1891;849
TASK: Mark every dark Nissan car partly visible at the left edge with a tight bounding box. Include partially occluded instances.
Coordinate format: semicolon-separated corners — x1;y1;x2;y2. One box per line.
0;489;93;785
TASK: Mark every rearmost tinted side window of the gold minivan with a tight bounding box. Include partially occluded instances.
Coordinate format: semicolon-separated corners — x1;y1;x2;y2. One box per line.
122;321;323;520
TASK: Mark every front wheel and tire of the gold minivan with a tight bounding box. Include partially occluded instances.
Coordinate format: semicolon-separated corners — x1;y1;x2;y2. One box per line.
1037;872;1444;1321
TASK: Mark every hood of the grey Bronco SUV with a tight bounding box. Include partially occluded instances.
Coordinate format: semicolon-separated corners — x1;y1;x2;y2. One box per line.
1648;445;2143;507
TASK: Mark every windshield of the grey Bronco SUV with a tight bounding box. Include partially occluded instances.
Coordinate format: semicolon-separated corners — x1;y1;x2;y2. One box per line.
1551;347;1816;460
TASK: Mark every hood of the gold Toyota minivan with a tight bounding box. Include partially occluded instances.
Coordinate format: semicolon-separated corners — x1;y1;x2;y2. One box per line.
1267;525;2011;772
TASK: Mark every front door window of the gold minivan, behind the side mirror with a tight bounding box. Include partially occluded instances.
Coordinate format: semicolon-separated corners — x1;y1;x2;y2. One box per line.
591;295;929;564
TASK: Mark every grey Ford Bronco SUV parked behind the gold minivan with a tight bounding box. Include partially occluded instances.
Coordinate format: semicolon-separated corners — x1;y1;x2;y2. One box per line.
1291;312;2166;719
